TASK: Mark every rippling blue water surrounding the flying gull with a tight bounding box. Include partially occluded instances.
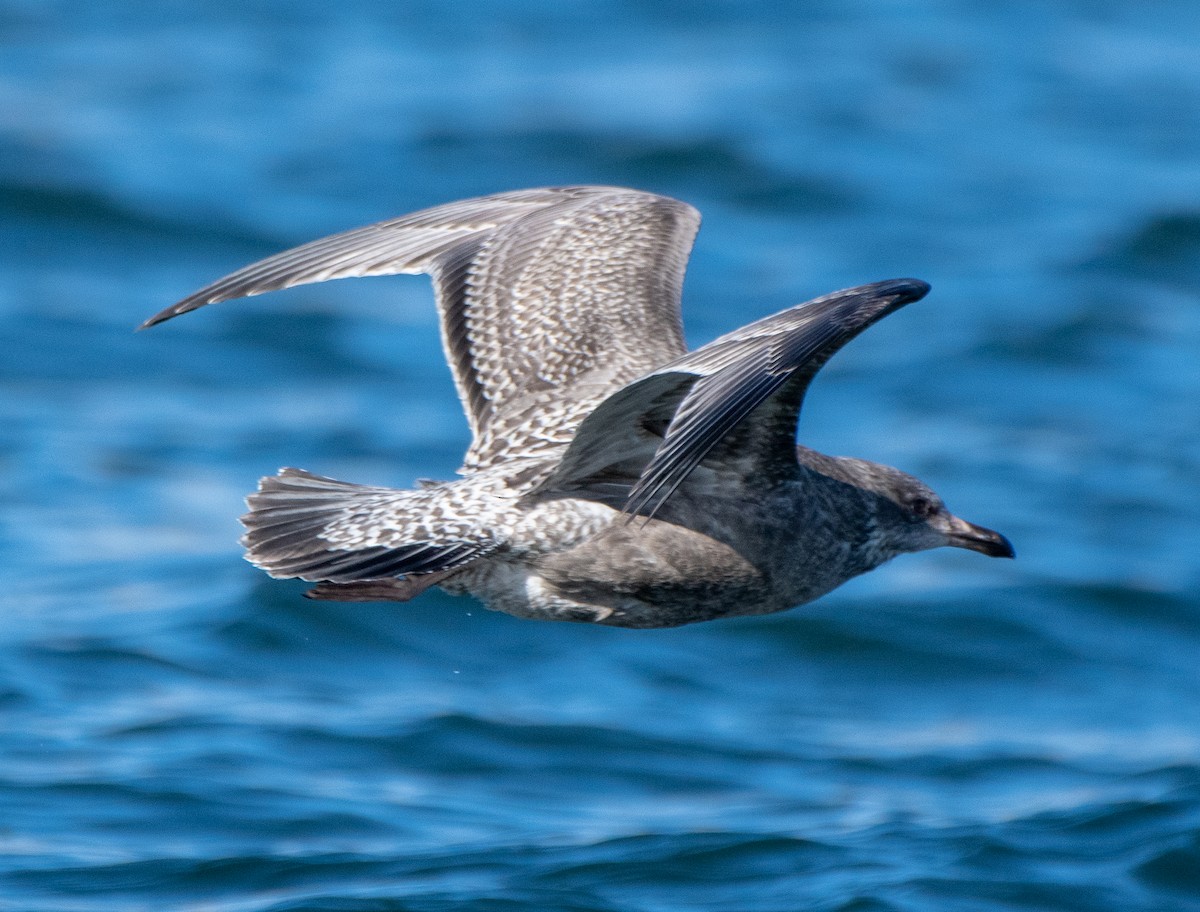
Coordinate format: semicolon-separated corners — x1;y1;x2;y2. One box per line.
0;0;1200;912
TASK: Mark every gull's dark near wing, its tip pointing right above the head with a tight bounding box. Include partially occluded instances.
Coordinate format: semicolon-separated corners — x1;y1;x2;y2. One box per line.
542;278;929;516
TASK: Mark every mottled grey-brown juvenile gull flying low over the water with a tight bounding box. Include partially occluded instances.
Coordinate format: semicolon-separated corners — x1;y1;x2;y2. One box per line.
143;187;1013;628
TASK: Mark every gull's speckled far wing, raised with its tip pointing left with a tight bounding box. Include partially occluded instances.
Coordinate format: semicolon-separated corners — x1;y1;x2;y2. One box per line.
143;187;700;468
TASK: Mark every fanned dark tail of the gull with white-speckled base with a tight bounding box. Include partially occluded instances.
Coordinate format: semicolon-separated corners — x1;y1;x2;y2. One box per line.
241;468;494;583
